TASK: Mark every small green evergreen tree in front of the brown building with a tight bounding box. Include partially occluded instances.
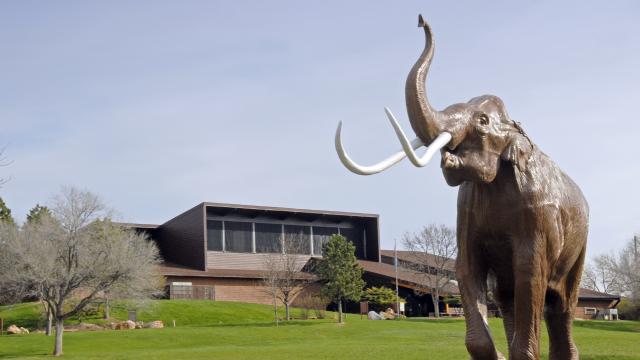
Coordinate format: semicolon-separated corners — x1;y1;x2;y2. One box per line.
316;235;364;323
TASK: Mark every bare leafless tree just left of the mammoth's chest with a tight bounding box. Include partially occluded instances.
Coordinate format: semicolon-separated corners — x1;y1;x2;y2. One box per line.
402;224;458;317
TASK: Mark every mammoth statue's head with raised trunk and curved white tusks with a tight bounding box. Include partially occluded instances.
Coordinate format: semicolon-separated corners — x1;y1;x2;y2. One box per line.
335;16;533;186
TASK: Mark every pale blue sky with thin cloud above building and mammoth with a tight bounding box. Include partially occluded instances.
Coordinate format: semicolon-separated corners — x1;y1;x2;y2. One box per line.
0;1;640;256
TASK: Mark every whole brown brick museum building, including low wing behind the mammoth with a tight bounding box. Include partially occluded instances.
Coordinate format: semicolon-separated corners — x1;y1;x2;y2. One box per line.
126;203;619;318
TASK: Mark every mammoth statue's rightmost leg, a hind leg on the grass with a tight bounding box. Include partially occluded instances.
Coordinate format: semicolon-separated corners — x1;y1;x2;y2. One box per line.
544;249;586;360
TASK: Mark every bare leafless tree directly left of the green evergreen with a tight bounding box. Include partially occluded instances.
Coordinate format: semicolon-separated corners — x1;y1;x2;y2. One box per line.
263;234;309;322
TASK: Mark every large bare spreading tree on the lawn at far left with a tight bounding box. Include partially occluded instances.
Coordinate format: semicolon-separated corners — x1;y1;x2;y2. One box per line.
0;188;162;356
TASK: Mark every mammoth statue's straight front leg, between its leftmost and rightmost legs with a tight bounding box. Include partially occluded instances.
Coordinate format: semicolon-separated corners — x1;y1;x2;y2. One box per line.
509;239;547;360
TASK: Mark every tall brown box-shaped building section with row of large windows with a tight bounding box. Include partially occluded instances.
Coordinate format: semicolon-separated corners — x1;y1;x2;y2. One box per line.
127;203;380;303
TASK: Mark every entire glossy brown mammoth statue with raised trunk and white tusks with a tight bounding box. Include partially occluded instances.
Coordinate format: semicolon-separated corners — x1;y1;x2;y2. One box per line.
335;17;589;359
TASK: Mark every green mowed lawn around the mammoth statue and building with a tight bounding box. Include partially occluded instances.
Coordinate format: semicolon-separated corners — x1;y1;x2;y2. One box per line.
0;301;640;359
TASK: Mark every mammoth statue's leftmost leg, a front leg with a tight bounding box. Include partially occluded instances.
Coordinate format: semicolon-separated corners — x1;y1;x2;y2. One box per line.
456;235;504;360
